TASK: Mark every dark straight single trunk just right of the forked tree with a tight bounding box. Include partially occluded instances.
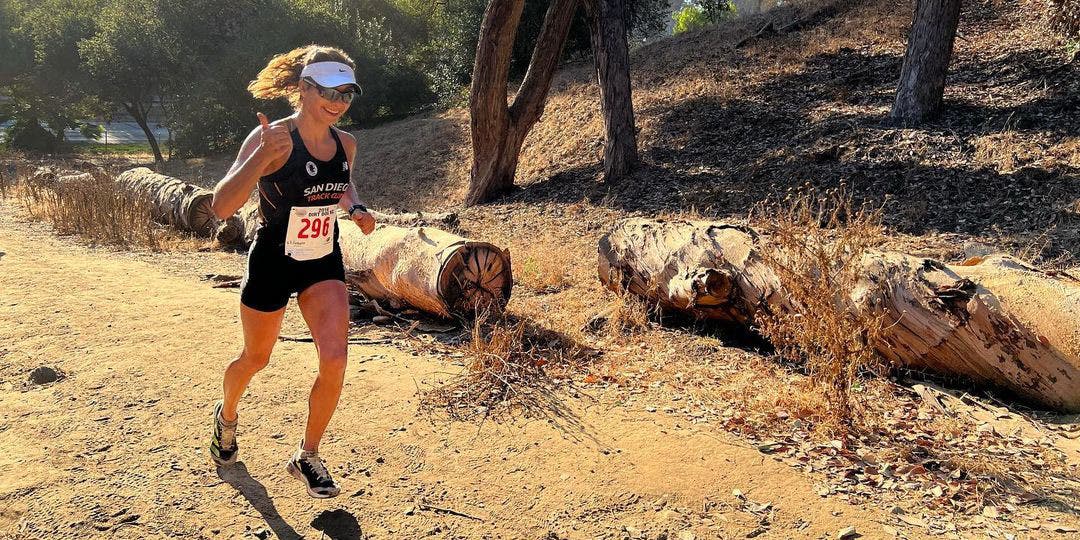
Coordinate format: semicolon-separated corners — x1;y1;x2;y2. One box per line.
585;0;637;181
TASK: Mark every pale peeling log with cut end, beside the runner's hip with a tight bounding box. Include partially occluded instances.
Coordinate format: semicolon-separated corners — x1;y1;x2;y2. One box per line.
338;218;513;318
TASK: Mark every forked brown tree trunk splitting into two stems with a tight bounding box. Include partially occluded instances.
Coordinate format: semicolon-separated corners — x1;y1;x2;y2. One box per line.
465;0;578;205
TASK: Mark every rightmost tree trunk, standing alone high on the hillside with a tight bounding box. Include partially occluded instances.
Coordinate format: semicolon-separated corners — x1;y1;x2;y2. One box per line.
889;0;961;125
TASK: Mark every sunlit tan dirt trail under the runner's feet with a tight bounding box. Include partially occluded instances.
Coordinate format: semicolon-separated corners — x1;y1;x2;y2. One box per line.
0;218;915;539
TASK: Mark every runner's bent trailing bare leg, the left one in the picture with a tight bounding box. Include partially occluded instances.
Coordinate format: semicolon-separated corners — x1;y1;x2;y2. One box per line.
221;305;285;422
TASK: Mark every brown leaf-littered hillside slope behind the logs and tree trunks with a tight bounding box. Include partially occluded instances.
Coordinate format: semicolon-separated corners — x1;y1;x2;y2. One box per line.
357;0;1080;256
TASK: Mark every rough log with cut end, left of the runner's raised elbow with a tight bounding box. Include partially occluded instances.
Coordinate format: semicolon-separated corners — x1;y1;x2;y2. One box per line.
117;167;219;237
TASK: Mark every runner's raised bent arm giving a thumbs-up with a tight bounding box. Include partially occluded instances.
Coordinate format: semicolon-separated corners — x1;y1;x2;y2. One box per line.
211;112;293;219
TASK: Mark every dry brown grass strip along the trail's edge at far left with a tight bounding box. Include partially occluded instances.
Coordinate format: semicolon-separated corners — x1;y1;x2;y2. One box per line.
16;170;163;251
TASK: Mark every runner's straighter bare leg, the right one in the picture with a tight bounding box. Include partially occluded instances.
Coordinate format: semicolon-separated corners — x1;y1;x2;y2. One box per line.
297;280;349;451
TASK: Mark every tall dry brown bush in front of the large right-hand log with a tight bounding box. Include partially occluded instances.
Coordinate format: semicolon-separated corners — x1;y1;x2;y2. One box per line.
758;187;885;432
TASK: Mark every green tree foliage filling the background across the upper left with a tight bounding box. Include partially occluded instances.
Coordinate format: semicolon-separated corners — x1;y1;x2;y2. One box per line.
0;0;667;156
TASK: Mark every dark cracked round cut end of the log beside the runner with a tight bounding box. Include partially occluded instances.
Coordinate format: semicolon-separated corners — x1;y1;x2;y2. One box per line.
438;242;513;313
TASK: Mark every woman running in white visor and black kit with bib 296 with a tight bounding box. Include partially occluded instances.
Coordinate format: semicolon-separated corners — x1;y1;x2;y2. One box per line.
210;45;375;498
